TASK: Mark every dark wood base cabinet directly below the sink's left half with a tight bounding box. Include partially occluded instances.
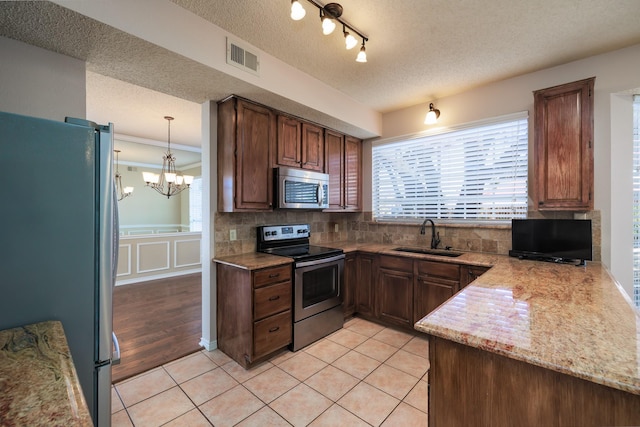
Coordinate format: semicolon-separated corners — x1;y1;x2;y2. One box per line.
376;255;414;328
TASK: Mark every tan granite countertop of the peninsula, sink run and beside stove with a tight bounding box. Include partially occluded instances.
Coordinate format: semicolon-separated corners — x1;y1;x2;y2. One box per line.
215;242;640;394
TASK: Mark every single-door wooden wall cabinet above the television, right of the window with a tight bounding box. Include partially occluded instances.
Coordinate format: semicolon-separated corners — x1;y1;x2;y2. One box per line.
534;78;595;211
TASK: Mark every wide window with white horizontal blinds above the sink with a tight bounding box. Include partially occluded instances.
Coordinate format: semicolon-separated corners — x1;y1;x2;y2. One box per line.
372;112;528;221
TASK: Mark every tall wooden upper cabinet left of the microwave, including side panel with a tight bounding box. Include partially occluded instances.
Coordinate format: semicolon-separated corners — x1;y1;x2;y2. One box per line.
218;97;276;212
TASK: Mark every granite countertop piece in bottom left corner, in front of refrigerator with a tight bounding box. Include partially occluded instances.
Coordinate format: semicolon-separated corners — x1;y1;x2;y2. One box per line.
0;321;93;426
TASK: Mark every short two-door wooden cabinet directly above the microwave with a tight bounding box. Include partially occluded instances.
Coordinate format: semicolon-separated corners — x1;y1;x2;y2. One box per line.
276;115;324;172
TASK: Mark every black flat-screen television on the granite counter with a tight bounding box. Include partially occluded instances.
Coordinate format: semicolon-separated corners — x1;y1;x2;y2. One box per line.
509;219;593;264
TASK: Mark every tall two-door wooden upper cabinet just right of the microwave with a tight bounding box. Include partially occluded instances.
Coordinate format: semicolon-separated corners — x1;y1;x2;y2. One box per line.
324;129;362;212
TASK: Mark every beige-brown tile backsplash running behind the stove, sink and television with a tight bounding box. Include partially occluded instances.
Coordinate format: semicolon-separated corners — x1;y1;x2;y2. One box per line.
214;210;601;261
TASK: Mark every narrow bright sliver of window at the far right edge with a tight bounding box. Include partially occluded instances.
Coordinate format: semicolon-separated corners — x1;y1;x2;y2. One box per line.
633;95;640;307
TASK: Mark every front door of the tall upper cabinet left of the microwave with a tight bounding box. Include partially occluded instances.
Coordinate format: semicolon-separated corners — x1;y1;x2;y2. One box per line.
234;100;275;210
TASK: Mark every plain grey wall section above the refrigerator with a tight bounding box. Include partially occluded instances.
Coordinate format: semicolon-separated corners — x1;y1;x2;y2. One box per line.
0;37;86;121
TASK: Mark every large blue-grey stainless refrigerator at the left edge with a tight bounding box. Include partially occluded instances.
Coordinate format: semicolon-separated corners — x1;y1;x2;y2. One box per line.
0;112;119;427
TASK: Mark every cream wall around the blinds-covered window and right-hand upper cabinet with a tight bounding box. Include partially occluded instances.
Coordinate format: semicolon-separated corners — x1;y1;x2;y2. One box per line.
372;45;640;295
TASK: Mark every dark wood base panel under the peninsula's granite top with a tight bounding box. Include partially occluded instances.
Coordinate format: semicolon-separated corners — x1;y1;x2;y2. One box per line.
428;336;640;427
